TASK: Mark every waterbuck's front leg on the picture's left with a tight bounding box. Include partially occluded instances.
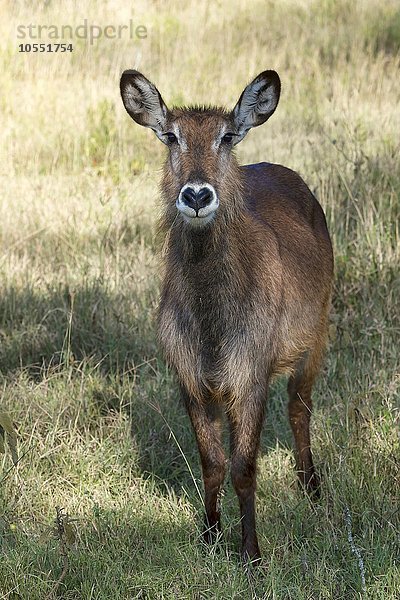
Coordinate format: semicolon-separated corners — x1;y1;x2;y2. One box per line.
182;390;226;543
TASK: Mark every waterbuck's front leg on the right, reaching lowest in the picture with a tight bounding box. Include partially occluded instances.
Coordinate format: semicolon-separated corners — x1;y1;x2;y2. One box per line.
229;394;266;562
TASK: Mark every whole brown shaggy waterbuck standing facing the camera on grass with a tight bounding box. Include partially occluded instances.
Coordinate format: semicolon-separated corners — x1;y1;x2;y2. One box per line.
120;71;333;561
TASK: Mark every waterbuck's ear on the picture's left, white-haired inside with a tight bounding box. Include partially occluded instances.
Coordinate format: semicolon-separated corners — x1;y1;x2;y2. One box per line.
120;70;168;143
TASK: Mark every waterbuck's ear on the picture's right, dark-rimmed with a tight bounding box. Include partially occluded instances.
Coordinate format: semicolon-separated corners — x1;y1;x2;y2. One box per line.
232;71;281;143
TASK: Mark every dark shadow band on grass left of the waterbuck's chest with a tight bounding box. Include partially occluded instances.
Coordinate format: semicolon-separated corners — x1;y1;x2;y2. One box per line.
0;280;157;377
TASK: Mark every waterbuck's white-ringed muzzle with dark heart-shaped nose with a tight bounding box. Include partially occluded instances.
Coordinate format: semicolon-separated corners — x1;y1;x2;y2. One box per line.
176;183;219;226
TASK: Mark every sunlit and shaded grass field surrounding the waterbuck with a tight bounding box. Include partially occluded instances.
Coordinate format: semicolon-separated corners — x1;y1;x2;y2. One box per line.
0;0;400;600
